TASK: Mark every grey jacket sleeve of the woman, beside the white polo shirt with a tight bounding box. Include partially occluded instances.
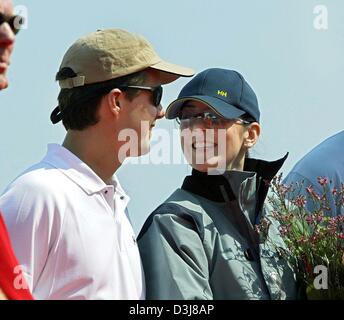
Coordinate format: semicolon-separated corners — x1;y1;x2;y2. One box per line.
138;213;213;300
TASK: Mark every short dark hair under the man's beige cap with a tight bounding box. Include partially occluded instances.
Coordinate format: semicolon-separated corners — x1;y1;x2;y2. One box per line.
56;68;146;130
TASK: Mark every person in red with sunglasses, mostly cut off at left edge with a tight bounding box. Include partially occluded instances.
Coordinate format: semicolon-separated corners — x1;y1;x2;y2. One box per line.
0;0;32;300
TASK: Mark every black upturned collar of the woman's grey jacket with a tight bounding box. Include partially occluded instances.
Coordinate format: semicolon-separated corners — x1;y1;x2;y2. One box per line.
182;154;288;212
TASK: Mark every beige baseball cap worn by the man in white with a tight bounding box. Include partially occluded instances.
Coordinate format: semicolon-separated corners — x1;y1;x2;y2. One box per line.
59;29;195;89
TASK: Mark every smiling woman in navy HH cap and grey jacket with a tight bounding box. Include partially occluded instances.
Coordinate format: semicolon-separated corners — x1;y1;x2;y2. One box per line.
139;69;296;299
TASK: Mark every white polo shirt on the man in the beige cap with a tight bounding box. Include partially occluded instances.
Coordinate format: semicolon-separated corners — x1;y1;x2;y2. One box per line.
0;144;145;299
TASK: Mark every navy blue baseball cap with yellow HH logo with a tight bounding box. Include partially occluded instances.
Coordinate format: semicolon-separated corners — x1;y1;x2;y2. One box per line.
166;68;260;122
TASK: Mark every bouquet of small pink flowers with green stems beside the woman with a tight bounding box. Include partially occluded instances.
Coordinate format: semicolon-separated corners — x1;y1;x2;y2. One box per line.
258;175;344;299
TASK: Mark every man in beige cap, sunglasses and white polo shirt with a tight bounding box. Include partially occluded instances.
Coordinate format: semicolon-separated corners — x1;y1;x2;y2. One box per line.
0;29;193;299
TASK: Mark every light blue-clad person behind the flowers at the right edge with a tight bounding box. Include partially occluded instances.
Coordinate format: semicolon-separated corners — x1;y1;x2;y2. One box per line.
284;131;344;217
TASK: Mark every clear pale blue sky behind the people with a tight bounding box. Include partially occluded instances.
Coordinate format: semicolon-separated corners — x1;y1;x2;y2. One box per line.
0;0;344;231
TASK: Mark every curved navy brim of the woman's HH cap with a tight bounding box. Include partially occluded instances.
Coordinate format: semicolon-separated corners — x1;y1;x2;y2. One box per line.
165;96;246;119
